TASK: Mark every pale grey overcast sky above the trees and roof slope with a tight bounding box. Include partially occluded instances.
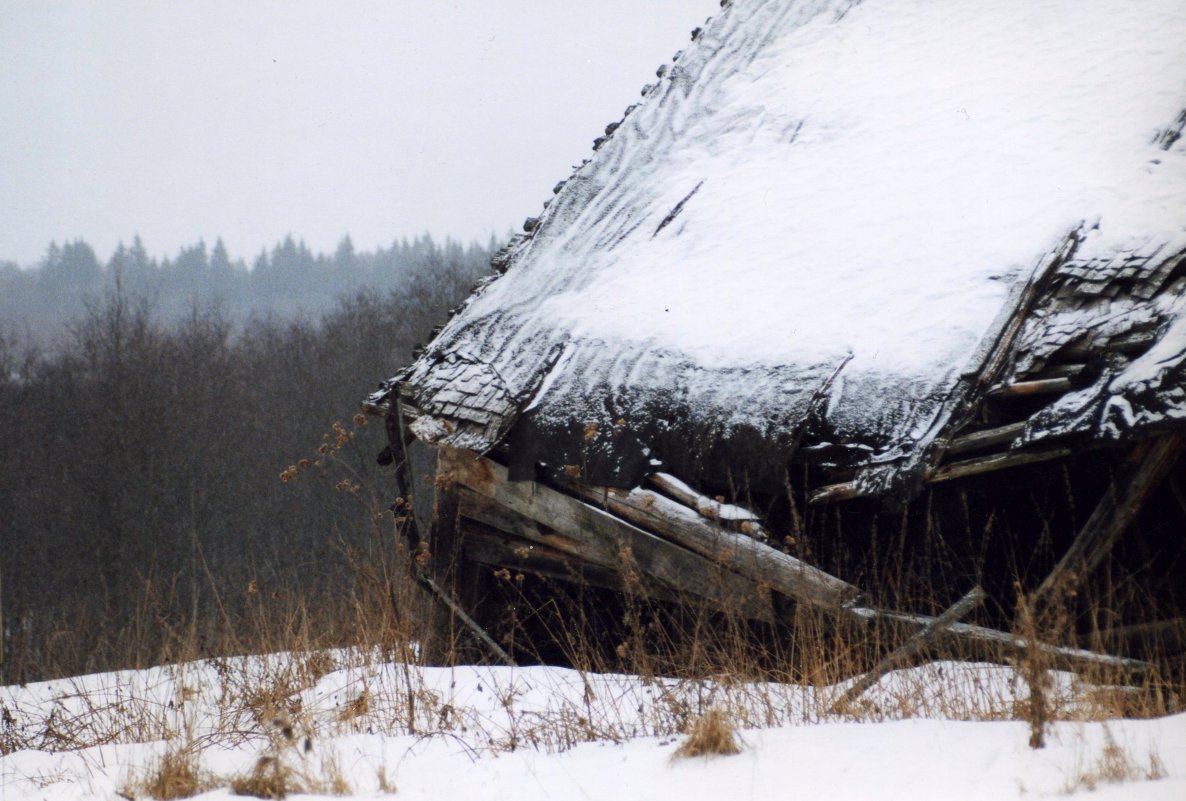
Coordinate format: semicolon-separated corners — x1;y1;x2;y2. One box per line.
0;0;719;265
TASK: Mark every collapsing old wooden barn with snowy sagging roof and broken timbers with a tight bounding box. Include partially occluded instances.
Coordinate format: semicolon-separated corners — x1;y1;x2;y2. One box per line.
368;0;1186;662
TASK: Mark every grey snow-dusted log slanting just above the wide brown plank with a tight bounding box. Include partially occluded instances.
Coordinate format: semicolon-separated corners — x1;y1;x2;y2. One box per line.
572;485;861;609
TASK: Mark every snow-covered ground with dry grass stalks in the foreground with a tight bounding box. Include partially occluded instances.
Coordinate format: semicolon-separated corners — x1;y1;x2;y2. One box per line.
0;653;1186;801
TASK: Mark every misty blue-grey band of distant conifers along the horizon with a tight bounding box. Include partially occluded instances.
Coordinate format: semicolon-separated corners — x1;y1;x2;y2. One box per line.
0;235;498;350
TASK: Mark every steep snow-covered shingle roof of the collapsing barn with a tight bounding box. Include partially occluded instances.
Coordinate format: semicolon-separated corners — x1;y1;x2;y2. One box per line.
377;0;1186;496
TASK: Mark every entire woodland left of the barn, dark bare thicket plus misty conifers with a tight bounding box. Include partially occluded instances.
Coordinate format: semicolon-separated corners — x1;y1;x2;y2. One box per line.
0;234;489;682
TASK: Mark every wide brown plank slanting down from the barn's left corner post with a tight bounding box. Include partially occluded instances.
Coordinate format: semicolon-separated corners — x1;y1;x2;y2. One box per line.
441;447;773;621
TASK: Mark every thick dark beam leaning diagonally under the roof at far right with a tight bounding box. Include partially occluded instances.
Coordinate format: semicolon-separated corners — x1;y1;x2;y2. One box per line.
1032;437;1184;600
